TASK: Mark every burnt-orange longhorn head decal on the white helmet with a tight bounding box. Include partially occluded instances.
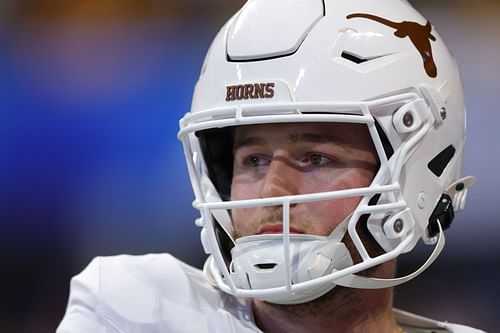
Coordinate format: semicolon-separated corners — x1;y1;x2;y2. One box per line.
347;13;437;78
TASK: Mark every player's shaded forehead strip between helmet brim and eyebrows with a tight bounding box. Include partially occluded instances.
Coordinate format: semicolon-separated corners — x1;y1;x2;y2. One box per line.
235;123;372;146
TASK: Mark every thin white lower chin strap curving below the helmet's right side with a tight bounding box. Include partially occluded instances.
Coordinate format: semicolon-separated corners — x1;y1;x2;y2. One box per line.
335;222;445;289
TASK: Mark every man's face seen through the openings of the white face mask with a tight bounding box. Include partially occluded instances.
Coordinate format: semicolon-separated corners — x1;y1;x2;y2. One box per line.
231;123;378;238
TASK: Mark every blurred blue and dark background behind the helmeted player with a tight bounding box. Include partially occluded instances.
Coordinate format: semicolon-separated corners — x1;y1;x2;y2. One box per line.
0;0;500;333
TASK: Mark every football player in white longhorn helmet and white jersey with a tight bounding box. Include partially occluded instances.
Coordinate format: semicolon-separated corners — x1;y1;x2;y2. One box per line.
58;0;480;333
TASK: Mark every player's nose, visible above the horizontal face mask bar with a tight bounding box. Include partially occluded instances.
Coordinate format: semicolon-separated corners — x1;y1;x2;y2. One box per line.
260;154;300;198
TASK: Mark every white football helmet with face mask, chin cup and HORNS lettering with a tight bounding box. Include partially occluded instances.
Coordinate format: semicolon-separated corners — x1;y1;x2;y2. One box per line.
178;0;474;304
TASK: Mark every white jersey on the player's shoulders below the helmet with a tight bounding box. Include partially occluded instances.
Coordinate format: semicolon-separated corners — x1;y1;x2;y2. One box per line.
56;254;481;333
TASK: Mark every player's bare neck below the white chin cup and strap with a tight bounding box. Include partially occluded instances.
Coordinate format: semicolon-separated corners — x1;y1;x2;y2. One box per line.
253;286;399;333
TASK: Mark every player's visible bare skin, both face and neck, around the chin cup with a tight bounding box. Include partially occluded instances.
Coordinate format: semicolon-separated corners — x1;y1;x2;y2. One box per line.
231;123;399;333
